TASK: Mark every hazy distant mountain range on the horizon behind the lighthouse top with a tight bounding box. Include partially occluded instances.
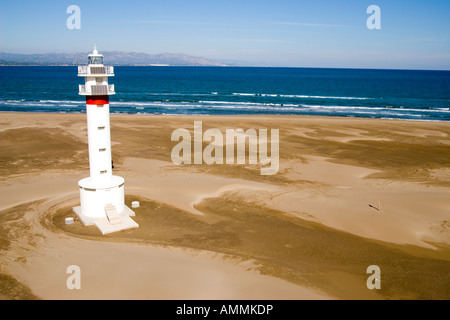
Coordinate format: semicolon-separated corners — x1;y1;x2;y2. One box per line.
0;51;232;66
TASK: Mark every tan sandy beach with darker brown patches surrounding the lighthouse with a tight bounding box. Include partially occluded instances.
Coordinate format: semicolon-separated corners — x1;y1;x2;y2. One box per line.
0;113;450;300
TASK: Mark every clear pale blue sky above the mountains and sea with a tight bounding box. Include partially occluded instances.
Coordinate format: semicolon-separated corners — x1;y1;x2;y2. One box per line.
0;0;450;70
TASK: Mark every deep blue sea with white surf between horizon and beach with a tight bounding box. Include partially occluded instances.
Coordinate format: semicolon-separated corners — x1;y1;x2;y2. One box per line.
0;66;450;121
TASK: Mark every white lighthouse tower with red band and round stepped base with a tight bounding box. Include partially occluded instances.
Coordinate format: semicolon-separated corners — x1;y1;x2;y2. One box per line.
73;48;138;234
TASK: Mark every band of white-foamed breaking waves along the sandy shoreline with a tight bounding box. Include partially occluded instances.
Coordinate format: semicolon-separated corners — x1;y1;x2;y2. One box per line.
0;95;450;121
